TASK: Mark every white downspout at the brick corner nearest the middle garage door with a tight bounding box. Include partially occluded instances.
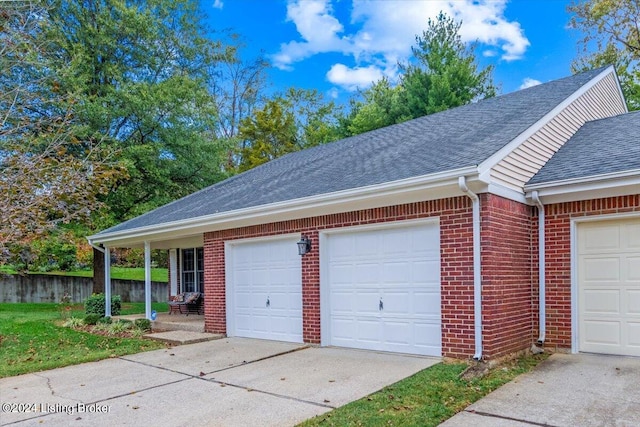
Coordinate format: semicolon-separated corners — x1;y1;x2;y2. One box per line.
458;176;482;360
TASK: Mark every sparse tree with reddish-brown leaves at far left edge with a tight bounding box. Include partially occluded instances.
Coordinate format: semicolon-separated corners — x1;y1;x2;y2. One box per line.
0;2;125;262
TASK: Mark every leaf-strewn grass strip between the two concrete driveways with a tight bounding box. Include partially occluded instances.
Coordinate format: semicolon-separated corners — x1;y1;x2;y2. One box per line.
300;354;546;427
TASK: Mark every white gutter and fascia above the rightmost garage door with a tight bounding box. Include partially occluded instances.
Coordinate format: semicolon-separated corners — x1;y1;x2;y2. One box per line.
524;169;640;204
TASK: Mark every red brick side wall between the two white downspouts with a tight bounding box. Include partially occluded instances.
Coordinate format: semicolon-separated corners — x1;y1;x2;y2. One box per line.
480;194;537;358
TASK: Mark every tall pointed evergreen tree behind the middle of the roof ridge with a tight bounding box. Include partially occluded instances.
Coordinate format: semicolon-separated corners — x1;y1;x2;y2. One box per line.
347;12;496;135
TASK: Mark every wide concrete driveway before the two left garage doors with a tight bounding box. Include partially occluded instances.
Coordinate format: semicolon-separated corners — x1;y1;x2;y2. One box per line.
0;338;439;426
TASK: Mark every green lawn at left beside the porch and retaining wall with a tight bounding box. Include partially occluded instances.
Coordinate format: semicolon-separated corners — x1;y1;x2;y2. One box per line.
0;303;168;378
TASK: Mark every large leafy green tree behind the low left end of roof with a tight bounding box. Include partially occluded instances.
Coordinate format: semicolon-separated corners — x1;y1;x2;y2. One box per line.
38;0;231;227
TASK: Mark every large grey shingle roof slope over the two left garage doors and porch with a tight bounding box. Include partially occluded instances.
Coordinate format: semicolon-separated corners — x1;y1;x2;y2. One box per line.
99;68;604;234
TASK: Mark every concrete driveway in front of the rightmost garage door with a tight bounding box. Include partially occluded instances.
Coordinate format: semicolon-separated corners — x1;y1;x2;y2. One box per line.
441;354;640;427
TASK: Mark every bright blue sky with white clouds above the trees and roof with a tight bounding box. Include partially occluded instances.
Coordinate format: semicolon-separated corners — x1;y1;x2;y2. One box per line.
201;0;580;101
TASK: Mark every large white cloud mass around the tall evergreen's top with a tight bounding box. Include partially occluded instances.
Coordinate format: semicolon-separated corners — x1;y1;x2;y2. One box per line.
271;0;529;90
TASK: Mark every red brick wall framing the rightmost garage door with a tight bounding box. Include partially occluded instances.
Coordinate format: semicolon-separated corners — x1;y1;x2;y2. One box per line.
535;194;640;350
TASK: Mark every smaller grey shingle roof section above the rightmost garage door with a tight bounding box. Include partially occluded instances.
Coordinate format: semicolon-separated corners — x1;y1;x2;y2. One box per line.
527;111;640;185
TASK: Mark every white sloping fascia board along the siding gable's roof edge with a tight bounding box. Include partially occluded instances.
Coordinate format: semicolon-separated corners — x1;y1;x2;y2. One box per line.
478;66;626;177
